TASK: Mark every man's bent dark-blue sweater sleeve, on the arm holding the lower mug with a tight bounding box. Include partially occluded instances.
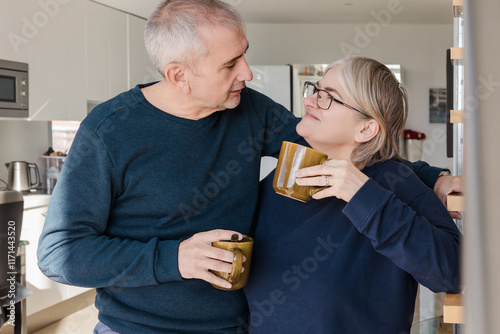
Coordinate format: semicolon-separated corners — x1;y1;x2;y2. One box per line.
38;123;182;288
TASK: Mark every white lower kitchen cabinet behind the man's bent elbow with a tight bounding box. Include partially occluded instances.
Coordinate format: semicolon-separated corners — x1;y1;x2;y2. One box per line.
21;195;90;316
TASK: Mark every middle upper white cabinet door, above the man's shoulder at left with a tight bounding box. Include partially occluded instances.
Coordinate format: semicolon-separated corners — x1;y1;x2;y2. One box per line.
86;1;128;102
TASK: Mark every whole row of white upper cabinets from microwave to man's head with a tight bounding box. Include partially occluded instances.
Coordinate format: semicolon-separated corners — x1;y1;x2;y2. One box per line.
0;0;161;121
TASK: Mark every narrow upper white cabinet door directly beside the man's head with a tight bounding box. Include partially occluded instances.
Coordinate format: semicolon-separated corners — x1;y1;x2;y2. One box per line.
128;14;161;88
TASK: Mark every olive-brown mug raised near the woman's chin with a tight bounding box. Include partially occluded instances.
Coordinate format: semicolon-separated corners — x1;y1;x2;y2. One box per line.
273;141;328;202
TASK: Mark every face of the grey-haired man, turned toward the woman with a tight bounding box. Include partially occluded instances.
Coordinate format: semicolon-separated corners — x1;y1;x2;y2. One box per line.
186;27;253;112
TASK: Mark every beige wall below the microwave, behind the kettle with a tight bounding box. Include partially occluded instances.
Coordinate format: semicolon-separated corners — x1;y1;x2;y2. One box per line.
0;120;50;184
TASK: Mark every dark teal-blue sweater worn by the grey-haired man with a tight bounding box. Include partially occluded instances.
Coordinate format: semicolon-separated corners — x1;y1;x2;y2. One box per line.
38;87;305;334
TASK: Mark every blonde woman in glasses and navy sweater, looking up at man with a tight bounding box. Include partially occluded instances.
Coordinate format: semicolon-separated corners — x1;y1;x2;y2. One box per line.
245;57;461;334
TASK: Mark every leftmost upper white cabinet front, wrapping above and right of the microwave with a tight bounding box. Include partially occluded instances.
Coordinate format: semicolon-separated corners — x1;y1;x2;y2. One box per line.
0;0;85;120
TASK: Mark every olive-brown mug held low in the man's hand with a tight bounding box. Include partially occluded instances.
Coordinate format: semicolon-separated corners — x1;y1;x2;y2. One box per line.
210;235;253;290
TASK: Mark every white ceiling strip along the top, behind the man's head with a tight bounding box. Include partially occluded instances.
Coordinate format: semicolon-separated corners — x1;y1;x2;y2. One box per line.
93;0;453;26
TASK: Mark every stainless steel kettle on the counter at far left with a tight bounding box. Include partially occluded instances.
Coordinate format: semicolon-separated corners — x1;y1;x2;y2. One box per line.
5;161;40;191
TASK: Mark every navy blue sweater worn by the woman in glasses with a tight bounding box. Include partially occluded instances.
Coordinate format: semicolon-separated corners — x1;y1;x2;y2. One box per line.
244;161;461;334
